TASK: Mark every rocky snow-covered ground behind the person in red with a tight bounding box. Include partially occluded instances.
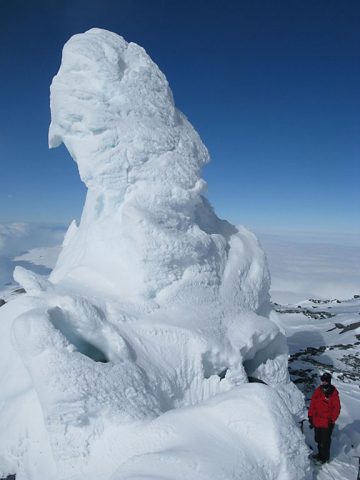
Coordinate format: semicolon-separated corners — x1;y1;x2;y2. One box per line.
275;296;360;480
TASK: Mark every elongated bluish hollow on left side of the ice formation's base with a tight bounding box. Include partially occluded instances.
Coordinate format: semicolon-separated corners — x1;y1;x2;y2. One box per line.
49;307;109;363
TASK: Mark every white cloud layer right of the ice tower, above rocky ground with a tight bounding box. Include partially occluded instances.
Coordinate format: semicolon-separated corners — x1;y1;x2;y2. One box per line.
259;234;360;303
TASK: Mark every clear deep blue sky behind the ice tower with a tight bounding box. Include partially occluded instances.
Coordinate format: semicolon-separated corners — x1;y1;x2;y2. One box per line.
0;0;360;232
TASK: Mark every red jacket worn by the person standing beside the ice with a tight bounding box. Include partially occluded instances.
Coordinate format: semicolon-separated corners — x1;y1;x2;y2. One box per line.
308;385;340;428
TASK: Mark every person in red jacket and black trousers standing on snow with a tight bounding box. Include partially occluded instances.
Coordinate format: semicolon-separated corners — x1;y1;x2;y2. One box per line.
308;373;340;463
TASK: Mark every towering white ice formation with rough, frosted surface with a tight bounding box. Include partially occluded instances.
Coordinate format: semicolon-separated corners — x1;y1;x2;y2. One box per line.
0;29;308;480
